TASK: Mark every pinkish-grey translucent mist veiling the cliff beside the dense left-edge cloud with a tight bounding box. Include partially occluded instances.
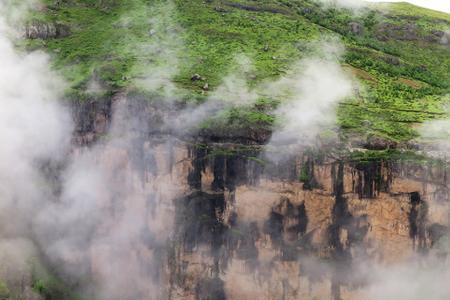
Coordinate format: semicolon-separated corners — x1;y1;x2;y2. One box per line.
34;98;179;299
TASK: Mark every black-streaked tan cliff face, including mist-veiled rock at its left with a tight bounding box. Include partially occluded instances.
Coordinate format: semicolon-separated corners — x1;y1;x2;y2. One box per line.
67;100;450;300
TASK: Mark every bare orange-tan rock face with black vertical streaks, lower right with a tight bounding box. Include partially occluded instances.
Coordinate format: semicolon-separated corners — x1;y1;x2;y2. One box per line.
169;150;449;299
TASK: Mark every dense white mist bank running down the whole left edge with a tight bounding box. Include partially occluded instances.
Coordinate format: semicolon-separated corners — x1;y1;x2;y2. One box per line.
0;2;71;299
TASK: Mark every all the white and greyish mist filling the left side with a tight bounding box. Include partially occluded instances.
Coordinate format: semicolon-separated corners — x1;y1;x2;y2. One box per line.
0;2;180;300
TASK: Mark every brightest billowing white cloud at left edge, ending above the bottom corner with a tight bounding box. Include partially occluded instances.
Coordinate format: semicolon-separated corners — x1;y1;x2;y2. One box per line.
0;0;71;239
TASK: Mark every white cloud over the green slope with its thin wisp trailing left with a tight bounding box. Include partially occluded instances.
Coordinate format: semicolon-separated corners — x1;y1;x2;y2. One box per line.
170;39;355;144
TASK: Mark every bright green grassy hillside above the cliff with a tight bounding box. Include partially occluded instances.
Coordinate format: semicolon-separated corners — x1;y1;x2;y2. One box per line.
23;0;450;145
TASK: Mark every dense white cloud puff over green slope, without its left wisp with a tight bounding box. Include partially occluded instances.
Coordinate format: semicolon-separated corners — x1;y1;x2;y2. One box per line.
265;41;356;159
